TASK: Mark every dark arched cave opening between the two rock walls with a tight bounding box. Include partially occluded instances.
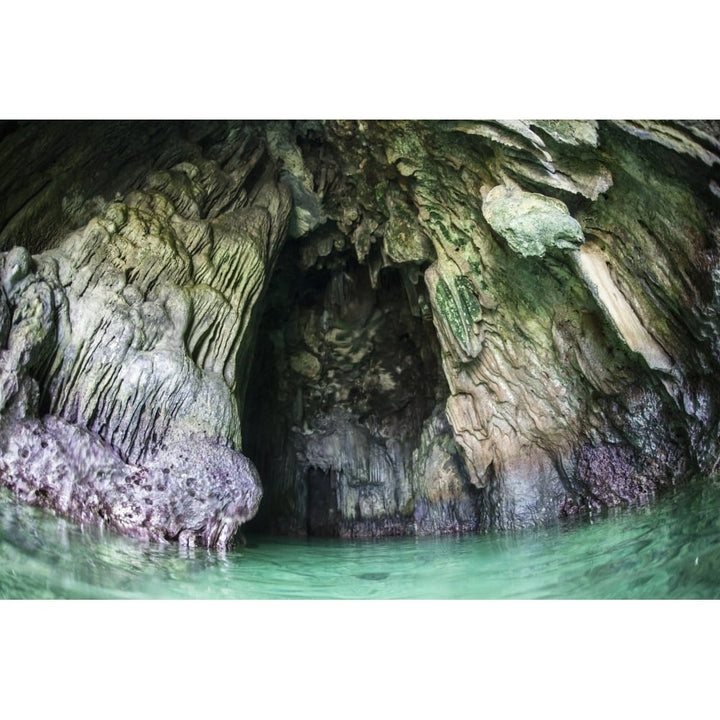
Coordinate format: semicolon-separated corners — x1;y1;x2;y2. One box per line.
243;233;448;537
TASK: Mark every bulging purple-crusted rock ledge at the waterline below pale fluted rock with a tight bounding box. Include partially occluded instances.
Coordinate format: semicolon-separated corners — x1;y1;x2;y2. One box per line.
0;416;262;549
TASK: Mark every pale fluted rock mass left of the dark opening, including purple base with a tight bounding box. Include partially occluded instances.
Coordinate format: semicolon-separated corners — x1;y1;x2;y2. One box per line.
0;122;291;546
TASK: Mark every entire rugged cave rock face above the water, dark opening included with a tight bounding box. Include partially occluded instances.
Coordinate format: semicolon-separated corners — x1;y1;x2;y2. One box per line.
0;121;720;547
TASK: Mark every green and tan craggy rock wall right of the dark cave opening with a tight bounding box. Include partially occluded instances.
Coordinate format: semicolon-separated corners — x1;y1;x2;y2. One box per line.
250;121;719;531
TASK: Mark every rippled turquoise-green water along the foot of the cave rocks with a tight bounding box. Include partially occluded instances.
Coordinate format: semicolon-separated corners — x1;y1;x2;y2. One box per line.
0;478;720;599
